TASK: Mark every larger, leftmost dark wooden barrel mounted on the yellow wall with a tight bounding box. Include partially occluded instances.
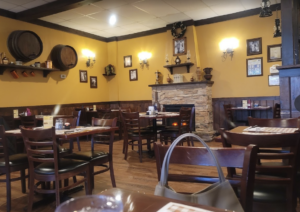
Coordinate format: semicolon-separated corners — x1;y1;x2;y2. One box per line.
7;30;43;62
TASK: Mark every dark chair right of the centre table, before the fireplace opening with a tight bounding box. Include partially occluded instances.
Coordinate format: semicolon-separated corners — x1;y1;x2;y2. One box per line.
159;107;195;146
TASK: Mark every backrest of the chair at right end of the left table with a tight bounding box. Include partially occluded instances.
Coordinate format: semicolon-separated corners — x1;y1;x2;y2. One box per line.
91;117;118;151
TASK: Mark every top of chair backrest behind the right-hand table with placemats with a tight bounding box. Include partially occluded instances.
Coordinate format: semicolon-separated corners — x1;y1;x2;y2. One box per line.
248;116;300;128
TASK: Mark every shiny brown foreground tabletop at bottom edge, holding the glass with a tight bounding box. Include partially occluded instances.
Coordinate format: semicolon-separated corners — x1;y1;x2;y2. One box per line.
99;188;229;212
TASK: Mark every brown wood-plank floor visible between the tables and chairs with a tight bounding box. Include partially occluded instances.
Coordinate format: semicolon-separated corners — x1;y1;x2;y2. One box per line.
0;137;300;212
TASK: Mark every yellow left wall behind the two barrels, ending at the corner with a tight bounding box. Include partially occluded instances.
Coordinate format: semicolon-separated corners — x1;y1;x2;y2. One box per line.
0;17;109;107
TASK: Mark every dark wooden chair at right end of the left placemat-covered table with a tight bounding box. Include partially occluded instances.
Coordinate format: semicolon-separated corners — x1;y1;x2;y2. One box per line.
66;117;117;188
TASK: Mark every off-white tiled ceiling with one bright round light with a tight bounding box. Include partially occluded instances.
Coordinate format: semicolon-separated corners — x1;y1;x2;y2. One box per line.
0;0;281;38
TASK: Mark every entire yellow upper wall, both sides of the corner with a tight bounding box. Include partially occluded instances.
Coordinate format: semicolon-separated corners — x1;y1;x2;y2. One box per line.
0;12;281;107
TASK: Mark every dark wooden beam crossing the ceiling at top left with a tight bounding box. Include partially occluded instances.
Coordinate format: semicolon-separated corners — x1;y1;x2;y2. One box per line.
16;0;101;21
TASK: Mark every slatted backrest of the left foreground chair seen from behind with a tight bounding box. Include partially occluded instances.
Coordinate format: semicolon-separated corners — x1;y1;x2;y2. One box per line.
21;127;58;175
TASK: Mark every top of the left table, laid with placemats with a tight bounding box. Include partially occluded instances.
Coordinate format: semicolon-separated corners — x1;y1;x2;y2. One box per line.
5;127;119;139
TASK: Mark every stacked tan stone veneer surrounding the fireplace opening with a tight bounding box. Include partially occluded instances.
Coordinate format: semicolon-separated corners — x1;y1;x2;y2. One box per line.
149;81;215;141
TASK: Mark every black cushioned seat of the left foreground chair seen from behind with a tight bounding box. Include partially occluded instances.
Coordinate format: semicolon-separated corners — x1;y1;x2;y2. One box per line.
34;159;88;175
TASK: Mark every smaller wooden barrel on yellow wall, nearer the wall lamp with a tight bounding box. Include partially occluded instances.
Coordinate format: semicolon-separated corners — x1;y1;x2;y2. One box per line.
51;44;78;71
